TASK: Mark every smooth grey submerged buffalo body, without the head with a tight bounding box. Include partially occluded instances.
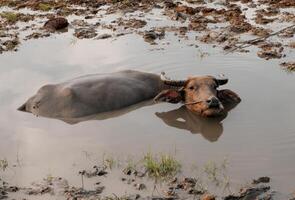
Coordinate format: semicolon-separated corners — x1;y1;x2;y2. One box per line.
19;70;163;118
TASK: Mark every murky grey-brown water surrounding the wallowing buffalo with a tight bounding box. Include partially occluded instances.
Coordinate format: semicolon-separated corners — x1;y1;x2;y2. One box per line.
0;30;295;196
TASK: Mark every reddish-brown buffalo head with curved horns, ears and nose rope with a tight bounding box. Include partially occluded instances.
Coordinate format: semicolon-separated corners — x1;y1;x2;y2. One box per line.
154;73;241;117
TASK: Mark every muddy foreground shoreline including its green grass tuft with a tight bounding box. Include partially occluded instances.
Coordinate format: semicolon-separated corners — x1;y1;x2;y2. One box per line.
0;153;295;200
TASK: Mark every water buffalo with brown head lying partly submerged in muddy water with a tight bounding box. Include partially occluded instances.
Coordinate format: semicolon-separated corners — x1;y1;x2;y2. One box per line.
18;70;240;119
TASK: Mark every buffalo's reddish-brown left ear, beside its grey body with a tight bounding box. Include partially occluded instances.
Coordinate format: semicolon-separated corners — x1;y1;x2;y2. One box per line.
154;89;183;103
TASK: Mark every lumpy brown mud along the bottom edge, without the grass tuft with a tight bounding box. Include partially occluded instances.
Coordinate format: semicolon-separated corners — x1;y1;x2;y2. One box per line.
0;166;293;200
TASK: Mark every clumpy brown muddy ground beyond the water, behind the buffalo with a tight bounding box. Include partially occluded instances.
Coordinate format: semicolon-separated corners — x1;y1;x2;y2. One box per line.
0;0;295;68
